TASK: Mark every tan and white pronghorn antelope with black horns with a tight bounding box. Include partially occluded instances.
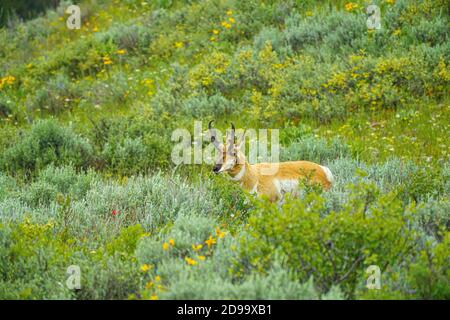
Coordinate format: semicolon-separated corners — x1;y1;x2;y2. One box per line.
208;121;333;202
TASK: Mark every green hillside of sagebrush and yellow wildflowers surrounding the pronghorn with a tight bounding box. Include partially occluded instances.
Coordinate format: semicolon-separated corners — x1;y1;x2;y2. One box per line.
0;0;450;300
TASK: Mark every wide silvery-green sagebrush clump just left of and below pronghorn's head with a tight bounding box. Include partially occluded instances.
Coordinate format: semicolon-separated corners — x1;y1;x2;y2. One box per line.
70;173;222;239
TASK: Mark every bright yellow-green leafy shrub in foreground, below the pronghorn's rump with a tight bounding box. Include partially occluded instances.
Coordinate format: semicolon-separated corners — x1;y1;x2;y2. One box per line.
240;185;415;297
